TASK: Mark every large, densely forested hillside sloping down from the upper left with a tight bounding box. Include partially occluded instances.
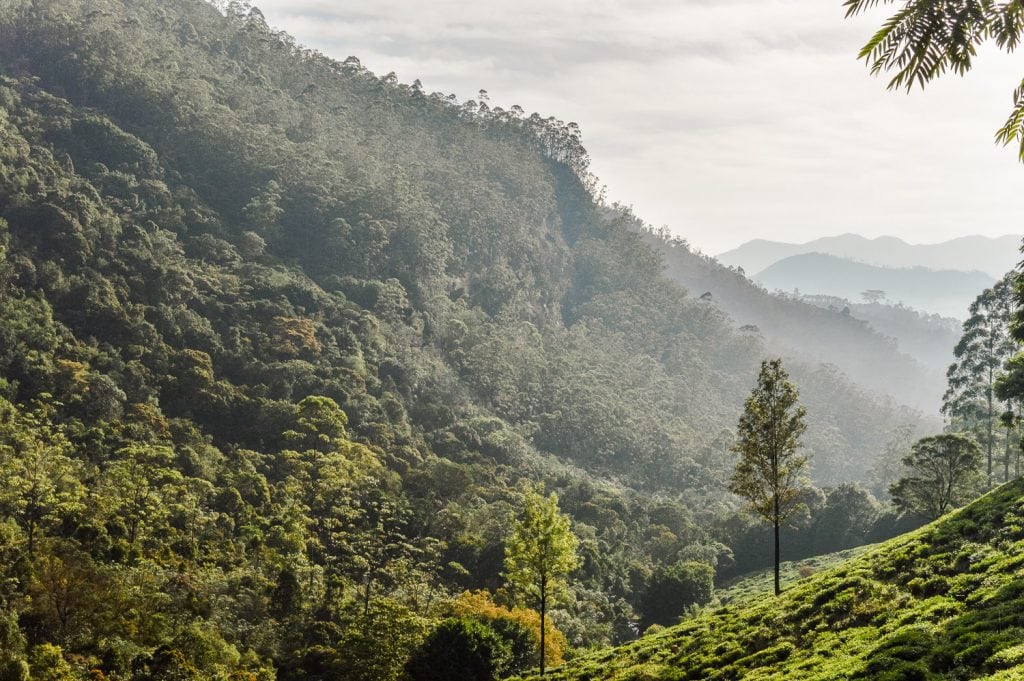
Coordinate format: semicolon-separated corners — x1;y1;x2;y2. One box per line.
0;0;942;680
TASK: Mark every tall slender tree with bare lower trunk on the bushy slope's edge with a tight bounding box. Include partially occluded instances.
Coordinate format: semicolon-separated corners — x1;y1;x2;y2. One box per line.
729;359;809;595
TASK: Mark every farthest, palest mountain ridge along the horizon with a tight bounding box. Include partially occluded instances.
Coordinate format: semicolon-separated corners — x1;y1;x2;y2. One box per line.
717;233;1021;278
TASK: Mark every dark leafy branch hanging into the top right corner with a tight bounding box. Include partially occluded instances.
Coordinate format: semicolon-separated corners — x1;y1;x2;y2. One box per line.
843;0;1024;157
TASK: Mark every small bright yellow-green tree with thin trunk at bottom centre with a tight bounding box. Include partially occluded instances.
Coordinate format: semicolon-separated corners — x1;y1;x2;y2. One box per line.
505;490;580;676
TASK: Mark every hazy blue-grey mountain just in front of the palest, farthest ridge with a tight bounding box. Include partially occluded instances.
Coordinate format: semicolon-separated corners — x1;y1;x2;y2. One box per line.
752;253;995;318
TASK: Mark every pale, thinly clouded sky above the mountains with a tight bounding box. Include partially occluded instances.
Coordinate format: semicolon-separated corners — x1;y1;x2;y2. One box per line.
249;0;1024;254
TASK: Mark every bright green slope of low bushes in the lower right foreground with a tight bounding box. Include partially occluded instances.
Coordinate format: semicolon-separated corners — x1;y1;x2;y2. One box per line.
532;480;1024;681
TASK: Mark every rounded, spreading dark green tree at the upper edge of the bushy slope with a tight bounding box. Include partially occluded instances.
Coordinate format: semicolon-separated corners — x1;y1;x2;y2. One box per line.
889;433;981;518
